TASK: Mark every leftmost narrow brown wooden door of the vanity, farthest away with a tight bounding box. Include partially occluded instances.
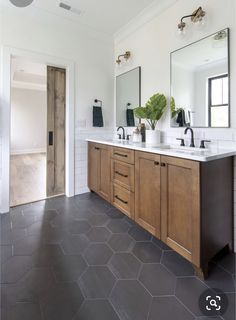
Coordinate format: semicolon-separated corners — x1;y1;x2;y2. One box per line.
88;142;100;192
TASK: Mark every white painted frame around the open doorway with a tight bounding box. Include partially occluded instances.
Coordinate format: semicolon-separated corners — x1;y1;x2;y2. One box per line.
0;46;75;213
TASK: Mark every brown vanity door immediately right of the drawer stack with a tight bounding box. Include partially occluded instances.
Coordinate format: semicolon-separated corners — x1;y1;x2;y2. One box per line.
135;152;160;237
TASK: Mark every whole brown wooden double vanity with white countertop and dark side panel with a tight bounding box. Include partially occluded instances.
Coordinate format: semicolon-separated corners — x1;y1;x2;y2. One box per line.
88;140;235;277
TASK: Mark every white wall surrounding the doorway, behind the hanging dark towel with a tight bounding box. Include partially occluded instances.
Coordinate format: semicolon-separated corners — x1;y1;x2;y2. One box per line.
0;7;114;205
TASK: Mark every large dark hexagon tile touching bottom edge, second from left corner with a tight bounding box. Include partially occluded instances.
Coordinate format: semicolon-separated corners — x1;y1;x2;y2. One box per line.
42;283;84;320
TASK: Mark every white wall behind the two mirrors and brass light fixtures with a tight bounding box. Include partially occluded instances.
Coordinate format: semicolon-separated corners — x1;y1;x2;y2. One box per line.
115;0;236;247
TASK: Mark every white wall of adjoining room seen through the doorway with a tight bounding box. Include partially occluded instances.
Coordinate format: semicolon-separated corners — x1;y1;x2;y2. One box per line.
11;88;47;154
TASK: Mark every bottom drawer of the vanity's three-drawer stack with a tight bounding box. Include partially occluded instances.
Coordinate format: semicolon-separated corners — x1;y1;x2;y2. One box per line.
112;184;134;219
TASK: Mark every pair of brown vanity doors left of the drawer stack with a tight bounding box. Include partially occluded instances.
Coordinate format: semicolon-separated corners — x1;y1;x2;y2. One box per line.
88;142;112;202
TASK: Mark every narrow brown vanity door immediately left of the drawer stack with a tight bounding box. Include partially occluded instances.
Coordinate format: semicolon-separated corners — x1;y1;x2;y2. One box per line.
97;145;111;201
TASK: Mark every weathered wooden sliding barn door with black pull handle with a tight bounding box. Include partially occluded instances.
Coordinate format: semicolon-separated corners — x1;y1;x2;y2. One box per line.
47;66;66;197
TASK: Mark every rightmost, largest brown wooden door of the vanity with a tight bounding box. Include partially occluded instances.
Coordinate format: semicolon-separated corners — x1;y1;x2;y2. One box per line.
161;156;200;266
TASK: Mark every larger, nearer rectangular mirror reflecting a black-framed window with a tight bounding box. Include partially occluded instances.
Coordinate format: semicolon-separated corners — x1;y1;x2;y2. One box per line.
171;29;230;128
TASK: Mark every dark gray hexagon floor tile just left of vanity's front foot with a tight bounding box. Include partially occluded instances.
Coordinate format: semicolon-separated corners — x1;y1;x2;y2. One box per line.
161;251;195;276
